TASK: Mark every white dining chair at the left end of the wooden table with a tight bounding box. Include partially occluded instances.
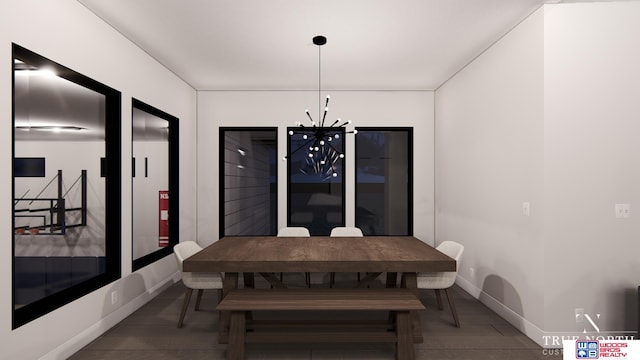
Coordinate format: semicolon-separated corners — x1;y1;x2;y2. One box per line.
173;241;222;328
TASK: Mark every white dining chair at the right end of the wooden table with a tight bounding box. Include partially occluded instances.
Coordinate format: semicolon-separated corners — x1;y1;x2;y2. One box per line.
417;241;464;327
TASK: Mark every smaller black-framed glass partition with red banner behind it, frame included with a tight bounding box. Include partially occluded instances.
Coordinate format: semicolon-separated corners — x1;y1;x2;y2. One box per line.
131;99;180;270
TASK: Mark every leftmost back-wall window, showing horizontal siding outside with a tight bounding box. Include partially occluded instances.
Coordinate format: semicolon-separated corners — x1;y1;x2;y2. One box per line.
220;129;278;236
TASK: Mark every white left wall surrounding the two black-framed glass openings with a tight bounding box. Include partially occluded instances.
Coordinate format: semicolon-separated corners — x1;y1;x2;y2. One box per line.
0;0;196;359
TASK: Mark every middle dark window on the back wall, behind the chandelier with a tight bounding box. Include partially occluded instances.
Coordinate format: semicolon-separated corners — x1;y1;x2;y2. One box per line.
287;128;344;235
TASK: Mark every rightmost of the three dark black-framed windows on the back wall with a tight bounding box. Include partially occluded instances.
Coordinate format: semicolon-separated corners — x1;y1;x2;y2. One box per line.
356;128;413;235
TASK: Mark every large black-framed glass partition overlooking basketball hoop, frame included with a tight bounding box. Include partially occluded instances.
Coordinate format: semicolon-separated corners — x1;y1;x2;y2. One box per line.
11;44;121;328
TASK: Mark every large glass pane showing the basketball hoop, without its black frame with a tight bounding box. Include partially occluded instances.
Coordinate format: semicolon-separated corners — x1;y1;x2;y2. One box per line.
13;59;106;309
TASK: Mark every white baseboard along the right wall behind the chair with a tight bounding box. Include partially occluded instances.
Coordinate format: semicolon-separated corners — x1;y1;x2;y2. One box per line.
456;276;550;348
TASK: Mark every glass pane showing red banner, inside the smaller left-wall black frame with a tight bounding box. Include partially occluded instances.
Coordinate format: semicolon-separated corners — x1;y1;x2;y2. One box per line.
132;107;170;260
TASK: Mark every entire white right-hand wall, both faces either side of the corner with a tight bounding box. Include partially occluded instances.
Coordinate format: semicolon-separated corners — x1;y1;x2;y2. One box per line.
436;2;640;346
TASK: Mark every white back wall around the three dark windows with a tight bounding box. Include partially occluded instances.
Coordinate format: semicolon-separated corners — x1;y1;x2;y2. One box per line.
197;91;433;244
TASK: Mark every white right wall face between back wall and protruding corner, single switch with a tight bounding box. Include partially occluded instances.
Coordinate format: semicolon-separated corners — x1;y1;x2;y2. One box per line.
435;5;545;333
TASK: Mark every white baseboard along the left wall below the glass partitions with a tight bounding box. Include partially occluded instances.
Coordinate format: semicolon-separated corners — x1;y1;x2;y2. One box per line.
40;272;180;360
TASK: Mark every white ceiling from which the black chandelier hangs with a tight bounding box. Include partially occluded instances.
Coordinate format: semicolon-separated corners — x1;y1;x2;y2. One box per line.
78;0;558;90
